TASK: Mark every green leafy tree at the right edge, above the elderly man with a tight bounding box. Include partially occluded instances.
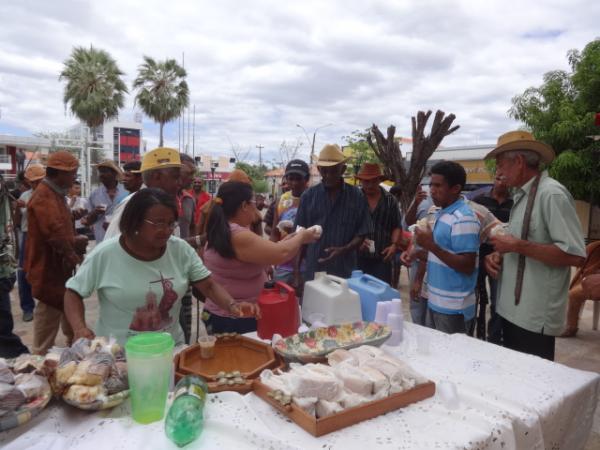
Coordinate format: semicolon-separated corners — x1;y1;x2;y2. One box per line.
509;39;600;203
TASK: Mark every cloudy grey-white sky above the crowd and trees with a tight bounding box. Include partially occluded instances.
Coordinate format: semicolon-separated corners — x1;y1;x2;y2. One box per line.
0;0;600;165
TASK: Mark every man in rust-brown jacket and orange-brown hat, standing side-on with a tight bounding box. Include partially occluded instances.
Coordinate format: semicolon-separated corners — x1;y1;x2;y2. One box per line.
24;151;87;355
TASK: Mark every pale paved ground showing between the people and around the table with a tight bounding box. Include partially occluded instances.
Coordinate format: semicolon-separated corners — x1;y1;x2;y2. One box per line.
11;272;600;450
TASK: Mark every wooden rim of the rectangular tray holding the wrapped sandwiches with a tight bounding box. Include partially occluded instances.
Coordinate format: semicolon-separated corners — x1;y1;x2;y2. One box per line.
254;380;435;437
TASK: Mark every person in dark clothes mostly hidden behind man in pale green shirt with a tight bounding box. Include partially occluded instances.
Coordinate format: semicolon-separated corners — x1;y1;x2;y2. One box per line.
473;179;513;345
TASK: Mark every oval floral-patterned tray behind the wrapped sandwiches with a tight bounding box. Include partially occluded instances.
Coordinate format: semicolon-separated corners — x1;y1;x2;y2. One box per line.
274;322;392;363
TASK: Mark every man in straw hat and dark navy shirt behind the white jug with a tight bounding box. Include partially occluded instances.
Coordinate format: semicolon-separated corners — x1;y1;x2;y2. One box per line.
295;144;373;280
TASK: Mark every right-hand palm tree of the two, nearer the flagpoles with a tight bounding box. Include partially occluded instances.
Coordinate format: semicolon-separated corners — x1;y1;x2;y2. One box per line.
133;56;189;147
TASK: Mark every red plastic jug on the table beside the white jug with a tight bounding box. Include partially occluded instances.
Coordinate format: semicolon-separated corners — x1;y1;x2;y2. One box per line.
257;281;300;339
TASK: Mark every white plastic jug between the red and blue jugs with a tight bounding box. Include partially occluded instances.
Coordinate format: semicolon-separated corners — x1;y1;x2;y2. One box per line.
302;272;362;325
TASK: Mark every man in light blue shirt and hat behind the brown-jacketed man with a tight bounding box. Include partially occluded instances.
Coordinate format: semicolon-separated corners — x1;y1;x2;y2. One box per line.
86;159;128;243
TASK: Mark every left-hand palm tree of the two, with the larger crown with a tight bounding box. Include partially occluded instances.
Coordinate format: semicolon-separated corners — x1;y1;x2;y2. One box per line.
59;46;127;141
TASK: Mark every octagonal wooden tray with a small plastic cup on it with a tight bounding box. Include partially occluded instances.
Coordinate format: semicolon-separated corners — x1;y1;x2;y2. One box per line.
174;335;285;393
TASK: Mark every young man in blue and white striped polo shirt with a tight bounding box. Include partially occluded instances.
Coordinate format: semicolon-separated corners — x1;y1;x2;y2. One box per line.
415;161;480;333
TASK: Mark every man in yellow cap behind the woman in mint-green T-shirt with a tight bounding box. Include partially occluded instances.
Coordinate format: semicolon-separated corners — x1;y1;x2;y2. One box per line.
104;147;181;239
